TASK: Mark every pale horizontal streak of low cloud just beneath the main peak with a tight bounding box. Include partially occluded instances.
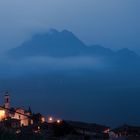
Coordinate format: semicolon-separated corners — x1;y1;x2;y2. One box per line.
25;57;102;69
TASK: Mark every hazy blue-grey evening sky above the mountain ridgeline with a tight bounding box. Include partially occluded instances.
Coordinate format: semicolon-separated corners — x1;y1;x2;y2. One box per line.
0;0;140;51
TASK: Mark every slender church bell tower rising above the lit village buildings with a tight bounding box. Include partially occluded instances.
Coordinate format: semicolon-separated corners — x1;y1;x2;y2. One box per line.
4;92;10;117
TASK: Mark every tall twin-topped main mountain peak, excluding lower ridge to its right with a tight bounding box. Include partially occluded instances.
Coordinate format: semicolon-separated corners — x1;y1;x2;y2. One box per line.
9;29;85;57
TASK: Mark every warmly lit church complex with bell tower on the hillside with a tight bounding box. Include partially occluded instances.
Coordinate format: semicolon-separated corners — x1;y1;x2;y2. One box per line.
0;93;45;126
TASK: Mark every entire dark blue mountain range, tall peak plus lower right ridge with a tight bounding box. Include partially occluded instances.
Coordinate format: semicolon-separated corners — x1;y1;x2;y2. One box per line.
8;29;138;59
